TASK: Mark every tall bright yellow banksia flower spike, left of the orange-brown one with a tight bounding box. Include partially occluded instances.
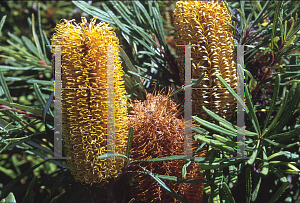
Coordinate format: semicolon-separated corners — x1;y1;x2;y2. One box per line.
52;18;128;186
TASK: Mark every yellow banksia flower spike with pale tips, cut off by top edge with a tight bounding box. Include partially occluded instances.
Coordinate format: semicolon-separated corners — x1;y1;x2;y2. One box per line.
174;1;237;119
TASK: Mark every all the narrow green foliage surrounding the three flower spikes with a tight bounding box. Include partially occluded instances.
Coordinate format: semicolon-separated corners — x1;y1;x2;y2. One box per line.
0;0;300;202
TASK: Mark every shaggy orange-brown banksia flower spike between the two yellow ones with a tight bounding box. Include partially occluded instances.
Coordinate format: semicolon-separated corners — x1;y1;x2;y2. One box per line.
129;89;203;203
